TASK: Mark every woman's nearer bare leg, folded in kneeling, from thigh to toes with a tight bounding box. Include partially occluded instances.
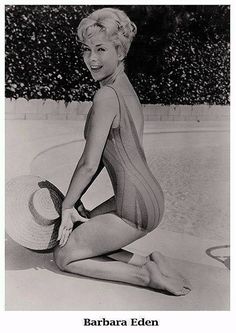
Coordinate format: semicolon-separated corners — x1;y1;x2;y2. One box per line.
54;213;189;295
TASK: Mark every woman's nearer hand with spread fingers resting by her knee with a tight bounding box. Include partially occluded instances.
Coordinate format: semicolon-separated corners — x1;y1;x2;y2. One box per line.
57;207;88;247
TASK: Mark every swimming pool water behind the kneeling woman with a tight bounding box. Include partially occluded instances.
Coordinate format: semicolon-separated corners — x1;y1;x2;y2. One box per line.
31;130;229;241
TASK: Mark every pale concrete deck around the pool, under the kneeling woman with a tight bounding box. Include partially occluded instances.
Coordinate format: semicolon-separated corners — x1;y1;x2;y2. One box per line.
6;120;229;311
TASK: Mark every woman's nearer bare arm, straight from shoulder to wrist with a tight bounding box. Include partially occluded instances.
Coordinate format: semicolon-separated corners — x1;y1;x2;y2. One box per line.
62;87;119;209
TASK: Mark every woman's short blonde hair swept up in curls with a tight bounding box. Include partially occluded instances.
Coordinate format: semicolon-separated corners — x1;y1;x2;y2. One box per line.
77;8;137;56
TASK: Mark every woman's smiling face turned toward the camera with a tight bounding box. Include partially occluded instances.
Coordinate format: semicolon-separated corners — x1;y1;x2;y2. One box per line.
83;32;122;81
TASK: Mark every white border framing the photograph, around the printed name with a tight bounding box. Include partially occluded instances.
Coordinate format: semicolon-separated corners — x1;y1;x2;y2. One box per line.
0;0;236;333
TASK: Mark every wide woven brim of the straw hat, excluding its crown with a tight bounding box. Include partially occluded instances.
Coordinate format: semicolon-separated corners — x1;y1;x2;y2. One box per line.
5;175;64;250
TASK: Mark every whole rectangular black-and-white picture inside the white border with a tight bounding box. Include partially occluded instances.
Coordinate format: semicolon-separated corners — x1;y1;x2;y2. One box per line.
4;2;231;316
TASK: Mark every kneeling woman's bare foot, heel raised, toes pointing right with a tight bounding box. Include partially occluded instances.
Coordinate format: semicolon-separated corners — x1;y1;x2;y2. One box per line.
146;252;192;296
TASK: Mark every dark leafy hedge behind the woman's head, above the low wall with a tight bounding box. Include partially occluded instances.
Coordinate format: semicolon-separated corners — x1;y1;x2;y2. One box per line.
5;5;230;105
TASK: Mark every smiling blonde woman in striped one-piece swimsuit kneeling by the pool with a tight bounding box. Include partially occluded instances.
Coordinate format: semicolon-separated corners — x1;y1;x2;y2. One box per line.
54;8;190;295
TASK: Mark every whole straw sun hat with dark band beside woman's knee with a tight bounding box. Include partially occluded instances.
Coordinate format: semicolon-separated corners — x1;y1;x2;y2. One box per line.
5;175;64;250
